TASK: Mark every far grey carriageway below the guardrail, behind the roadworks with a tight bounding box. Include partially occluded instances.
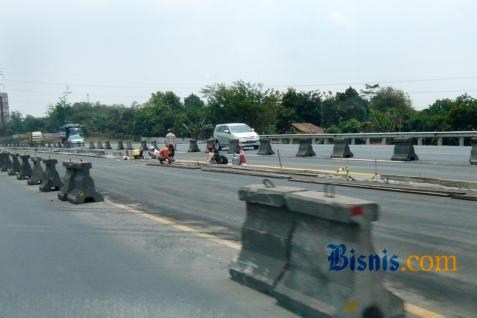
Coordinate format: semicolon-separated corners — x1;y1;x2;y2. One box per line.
173;144;477;181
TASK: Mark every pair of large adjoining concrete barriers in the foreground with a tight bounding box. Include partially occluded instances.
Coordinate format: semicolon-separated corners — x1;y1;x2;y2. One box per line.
229;181;405;318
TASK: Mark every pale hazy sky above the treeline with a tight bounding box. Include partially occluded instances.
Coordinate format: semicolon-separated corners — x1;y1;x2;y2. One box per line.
0;0;477;116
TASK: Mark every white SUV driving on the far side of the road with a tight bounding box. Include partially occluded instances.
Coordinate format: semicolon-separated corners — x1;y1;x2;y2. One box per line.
214;123;260;150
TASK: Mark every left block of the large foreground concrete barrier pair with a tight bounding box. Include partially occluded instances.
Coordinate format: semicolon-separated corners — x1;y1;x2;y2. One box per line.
229;185;303;293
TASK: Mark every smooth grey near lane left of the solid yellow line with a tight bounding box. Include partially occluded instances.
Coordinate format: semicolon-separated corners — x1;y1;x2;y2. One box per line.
0;173;294;318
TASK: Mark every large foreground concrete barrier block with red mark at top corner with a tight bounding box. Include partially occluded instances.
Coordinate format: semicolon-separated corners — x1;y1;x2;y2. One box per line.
274;191;404;318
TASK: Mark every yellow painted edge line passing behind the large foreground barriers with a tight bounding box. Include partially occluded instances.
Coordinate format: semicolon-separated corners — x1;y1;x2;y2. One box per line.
104;198;444;318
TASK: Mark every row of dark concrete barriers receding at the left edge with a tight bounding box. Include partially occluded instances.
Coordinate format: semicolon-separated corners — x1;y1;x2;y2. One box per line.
0;151;103;204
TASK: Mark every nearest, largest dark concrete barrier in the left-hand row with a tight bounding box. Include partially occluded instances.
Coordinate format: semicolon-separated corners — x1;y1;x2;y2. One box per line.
58;161;104;204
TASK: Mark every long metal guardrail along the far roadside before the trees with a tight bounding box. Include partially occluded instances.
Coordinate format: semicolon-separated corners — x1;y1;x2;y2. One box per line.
260;131;477;139
